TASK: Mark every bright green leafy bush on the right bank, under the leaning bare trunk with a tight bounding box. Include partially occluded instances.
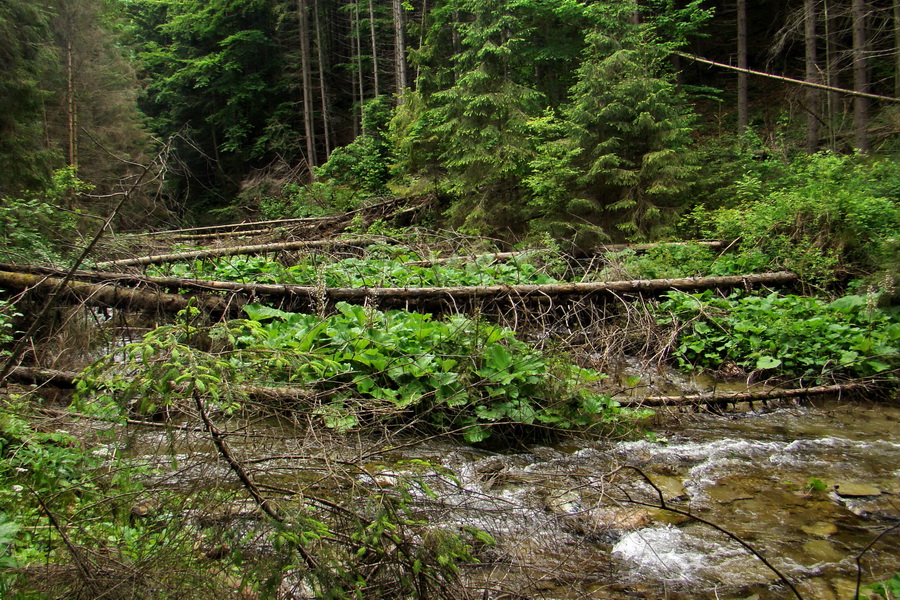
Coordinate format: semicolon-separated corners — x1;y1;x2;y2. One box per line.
692;153;900;285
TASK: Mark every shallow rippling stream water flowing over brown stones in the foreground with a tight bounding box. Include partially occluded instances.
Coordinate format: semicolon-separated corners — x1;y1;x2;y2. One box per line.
107;400;900;600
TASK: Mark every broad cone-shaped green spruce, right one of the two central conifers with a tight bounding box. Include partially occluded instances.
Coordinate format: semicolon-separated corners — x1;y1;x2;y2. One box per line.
527;2;696;243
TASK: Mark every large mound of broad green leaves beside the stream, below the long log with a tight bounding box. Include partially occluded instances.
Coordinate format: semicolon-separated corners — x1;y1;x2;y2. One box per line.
79;303;619;442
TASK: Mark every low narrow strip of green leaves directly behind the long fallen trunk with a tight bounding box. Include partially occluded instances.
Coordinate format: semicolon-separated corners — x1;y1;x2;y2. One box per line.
149;250;557;287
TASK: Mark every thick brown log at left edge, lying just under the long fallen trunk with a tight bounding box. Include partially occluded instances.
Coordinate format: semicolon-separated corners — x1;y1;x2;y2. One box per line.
0;271;229;315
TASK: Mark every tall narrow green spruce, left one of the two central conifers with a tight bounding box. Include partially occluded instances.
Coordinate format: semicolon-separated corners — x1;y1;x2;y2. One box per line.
418;0;545;230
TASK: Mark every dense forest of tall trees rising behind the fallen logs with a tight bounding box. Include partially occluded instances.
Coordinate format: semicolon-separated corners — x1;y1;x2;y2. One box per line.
0;0;900;246
